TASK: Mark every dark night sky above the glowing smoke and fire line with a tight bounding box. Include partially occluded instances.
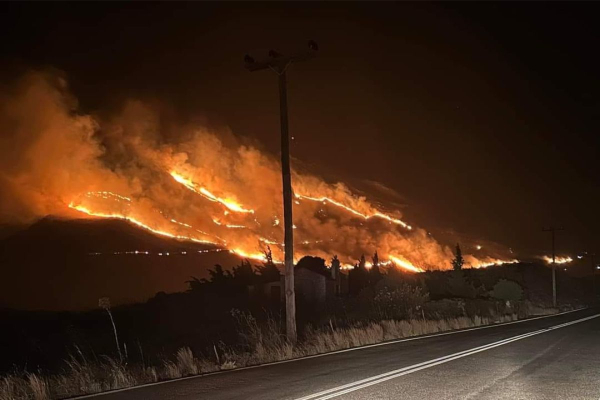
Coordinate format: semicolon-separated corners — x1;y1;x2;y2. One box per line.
0;2;600;260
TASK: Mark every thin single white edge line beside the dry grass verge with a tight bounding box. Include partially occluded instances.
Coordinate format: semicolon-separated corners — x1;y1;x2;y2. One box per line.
69;307;588;400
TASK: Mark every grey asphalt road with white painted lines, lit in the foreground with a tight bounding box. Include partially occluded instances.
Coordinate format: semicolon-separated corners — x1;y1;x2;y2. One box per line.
83;309;600;400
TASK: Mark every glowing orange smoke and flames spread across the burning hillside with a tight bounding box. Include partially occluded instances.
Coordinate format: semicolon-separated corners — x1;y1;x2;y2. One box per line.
0;72;508;269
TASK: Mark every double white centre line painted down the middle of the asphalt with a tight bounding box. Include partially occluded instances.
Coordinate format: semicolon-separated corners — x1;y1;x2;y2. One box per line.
296;314;600;400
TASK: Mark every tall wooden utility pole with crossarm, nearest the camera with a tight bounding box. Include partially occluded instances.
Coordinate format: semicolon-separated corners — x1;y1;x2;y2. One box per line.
244;40;318;343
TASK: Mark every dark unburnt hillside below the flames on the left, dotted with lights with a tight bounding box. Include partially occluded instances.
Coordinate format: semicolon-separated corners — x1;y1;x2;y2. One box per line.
0;217;244;310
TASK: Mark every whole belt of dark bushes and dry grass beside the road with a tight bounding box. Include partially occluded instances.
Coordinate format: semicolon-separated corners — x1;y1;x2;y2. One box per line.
0;252;585;400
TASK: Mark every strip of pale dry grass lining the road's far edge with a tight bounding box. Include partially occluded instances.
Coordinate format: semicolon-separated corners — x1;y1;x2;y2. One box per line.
0;309;542;400
